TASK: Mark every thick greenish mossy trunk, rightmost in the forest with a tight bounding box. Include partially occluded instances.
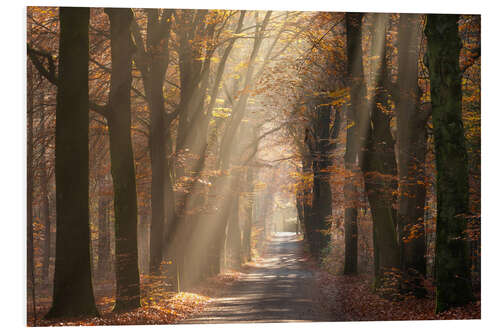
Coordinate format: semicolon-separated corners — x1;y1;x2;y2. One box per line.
425;14;473;312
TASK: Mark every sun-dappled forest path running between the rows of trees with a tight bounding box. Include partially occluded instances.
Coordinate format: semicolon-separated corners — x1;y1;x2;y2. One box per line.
180;232;342;324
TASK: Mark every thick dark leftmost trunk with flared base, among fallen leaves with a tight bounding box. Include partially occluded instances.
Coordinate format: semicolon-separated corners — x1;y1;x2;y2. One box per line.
46;8;98;318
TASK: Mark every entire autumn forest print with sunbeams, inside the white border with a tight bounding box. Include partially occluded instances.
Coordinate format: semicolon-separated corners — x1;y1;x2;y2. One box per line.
23;7;481;326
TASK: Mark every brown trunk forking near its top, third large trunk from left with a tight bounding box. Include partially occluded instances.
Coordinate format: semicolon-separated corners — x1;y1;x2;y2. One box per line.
133;9;175;274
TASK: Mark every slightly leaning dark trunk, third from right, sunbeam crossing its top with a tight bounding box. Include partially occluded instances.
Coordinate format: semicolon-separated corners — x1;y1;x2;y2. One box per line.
361;14;400;290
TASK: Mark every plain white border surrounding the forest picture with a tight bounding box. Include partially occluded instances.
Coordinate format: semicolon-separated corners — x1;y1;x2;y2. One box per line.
0;0;500;333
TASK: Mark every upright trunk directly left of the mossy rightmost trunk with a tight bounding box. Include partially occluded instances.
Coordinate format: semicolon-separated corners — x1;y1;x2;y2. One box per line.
393;14;428;296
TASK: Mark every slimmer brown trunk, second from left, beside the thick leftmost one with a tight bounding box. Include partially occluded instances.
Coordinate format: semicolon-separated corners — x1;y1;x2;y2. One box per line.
105;8;141;311
